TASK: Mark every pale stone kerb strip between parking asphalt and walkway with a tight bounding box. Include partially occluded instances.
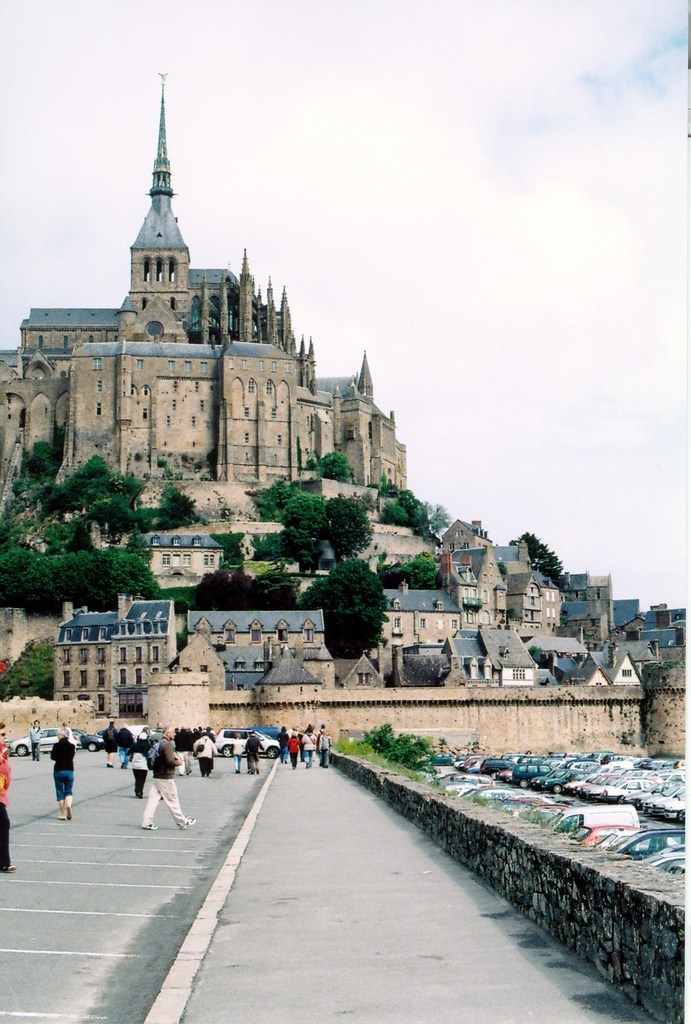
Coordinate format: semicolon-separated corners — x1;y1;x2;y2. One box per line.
144;761;278;1024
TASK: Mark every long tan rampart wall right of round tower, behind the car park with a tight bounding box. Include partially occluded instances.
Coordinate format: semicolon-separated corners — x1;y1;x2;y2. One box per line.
202;686;685;756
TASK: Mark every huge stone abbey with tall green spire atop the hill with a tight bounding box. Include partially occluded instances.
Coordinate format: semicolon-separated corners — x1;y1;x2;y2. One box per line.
0;83;406;491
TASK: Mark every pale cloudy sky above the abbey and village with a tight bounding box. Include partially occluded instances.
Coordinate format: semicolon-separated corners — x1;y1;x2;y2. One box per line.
0;0;688;608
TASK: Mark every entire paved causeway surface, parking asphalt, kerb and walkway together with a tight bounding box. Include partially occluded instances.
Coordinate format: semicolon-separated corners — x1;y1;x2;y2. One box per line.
0;751;663;1024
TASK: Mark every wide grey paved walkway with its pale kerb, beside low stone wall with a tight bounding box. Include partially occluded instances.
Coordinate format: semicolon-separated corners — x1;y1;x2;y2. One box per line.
146;764;651;1024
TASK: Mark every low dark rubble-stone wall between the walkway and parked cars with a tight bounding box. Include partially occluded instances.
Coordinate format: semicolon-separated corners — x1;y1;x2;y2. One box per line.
334;754;684;1024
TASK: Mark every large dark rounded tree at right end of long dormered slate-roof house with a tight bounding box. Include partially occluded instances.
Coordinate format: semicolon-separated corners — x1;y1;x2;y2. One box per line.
298;558;386;657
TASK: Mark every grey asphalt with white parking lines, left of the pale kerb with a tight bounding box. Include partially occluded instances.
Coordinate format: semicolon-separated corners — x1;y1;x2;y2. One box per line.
0;750;269;1024
